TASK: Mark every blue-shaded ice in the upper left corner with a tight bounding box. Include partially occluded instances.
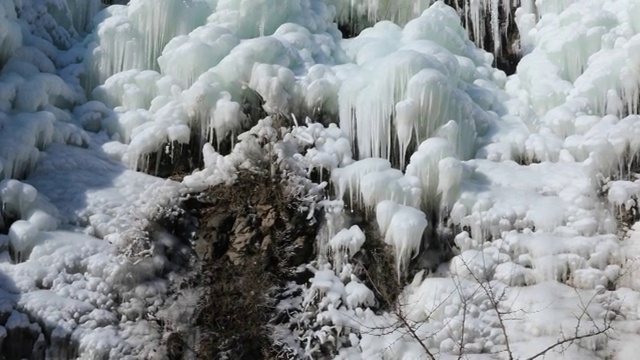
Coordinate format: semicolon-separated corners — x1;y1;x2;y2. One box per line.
0;0;102;179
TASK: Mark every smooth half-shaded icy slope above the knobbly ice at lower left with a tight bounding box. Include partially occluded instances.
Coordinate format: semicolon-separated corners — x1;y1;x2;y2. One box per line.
28;140;181;248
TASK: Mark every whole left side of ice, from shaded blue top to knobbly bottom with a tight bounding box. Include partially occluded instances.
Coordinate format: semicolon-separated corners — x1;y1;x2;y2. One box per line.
0;0;187;359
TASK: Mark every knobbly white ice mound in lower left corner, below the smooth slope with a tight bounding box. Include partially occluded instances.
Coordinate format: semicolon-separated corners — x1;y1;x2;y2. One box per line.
0;201;176;358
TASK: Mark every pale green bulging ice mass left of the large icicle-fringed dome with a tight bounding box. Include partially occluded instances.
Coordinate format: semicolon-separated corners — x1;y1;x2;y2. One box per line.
87;0;350;167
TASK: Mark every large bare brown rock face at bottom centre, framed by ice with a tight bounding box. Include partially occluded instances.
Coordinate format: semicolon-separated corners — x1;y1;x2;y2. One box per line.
196;172;317;359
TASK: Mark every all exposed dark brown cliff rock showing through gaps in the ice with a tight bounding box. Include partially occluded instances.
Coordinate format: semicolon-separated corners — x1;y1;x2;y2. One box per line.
148;0;520;359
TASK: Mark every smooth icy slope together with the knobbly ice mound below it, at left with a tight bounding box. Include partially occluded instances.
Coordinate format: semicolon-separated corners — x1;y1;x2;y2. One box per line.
0;136;186;358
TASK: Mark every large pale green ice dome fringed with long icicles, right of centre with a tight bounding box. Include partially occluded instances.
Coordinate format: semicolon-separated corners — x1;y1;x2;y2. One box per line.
339;4;495;168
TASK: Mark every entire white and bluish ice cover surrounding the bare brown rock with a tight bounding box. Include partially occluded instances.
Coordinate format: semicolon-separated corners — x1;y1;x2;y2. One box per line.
0;0;640;359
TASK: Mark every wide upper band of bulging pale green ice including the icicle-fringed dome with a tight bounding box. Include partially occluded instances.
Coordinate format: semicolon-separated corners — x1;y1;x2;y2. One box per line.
86;0;503;174
